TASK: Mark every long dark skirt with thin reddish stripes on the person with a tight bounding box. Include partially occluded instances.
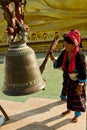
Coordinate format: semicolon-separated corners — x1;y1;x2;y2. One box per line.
62;72;86;112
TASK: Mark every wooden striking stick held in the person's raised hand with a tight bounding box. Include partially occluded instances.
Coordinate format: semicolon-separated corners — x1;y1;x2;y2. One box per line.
40;37;59;73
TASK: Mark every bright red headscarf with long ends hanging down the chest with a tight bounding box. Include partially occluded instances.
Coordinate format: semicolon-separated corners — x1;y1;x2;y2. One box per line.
62;29;81;72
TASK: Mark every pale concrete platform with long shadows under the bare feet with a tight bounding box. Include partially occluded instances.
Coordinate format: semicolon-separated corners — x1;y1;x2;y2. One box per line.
0;98;86;130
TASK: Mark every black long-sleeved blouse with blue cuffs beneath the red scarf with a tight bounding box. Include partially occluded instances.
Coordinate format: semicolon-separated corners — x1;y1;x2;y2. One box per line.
53;49;87;82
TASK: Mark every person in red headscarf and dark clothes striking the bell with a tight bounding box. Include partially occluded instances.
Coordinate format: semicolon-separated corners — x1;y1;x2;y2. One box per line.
50;29;87;122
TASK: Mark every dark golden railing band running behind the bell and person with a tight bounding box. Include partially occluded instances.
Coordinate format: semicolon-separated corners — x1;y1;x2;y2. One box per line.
0;38;87;54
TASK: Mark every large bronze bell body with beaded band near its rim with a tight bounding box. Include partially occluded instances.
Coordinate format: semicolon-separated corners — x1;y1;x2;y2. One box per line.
2;42;45;96
